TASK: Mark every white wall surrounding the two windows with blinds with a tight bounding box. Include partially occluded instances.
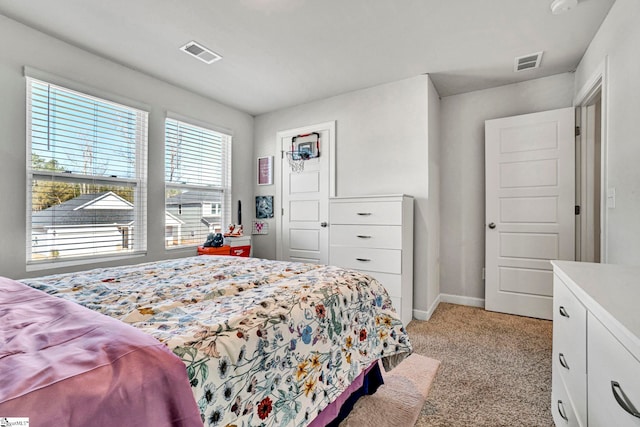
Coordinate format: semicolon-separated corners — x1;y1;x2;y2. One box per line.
0;15;254;278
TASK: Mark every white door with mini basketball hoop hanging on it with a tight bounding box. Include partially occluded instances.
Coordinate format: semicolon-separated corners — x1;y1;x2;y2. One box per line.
277;122;335;264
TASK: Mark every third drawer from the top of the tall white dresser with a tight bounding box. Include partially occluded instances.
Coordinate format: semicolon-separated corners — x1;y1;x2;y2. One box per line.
329;245;402;274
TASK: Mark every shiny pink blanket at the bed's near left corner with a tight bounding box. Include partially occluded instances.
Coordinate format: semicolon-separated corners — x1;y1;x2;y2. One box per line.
0;278;202;427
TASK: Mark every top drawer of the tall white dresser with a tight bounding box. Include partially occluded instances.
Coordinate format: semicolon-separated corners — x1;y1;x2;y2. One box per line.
329;202;402;225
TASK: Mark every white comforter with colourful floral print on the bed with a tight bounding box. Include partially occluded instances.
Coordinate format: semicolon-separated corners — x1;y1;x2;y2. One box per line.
23;256;411;426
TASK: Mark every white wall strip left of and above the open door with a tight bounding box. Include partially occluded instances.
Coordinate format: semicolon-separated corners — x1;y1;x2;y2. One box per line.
440;73;574;305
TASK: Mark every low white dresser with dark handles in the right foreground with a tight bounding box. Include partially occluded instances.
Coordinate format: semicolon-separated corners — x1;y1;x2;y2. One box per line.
551;261;640;427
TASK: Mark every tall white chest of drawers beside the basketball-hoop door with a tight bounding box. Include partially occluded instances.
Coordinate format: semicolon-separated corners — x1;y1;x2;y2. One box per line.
329;194;413;326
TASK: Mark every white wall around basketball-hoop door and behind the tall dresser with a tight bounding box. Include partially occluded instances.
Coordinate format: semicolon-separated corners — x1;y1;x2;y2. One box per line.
253;76;437;310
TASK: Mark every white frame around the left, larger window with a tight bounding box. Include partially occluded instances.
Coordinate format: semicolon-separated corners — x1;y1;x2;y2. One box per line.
25;73;149;271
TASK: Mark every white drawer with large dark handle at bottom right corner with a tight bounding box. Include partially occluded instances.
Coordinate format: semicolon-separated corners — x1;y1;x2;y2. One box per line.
587;314;640;427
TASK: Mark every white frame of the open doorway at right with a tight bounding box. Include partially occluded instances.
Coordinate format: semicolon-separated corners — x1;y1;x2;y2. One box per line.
573;56;615;263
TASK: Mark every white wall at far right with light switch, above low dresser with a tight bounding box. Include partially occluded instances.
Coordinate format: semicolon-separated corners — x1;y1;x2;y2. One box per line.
575;0;640;265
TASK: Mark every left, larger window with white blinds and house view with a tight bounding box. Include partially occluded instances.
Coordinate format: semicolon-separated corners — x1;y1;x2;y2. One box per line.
27;77;147;263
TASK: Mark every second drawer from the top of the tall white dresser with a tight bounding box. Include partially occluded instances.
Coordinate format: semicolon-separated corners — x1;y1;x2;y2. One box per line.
329;224;402;249
